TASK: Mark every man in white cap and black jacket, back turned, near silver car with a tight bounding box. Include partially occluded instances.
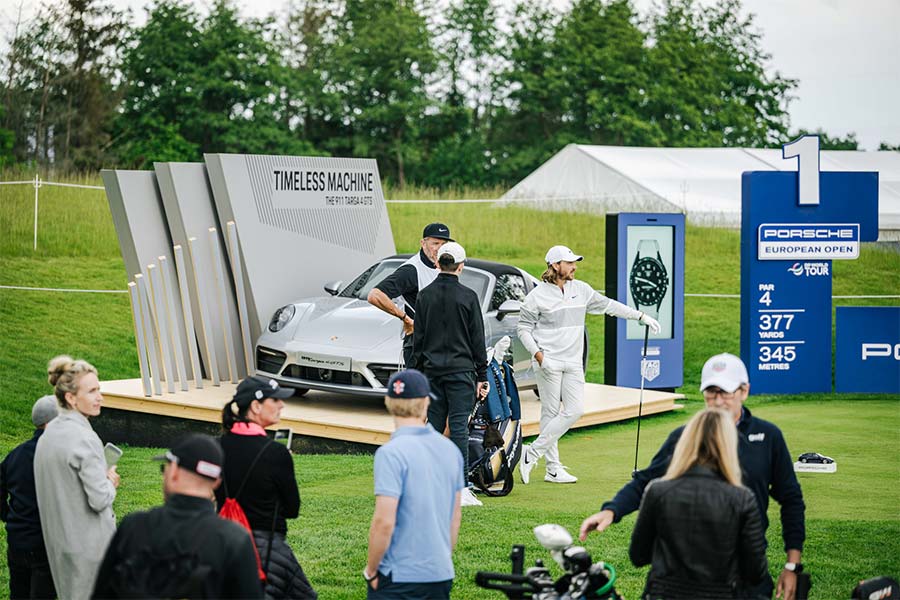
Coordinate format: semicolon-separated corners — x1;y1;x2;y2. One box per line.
411;242;488;506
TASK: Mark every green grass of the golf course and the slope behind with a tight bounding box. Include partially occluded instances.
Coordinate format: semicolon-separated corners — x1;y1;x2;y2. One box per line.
0;175;900;599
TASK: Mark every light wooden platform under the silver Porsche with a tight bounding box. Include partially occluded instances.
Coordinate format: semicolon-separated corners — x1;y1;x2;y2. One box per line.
100;379;684;446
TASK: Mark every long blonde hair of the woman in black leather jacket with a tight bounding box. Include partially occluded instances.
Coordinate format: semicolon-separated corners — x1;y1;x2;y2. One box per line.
663;408;741;486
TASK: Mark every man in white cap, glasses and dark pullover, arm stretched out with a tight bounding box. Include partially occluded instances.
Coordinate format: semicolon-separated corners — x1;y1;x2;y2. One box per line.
580;354;806;600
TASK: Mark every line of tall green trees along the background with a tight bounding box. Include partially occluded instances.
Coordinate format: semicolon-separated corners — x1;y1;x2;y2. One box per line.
0;0;884;187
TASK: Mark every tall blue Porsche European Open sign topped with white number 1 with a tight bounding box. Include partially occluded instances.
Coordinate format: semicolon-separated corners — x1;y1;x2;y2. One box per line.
741;136;878;394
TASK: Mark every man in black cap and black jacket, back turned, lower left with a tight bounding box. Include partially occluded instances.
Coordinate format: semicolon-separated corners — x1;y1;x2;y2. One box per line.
93;434;263;599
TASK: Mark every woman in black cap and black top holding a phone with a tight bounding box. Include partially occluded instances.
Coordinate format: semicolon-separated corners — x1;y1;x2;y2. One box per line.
216;377;317;599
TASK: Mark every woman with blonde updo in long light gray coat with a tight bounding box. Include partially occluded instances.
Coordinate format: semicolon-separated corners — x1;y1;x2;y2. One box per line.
34;356;119;600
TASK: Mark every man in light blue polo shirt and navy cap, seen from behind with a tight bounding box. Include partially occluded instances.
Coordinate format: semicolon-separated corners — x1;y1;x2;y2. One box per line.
363;369;466;600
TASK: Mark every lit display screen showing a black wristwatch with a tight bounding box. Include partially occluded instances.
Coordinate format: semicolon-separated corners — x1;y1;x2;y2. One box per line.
625;225;675;340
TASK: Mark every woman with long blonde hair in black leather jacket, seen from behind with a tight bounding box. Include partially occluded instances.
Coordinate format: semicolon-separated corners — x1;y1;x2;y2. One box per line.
628;409;768;600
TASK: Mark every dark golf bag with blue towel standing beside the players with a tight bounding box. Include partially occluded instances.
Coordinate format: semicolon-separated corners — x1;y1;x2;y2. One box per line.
468;359;522;496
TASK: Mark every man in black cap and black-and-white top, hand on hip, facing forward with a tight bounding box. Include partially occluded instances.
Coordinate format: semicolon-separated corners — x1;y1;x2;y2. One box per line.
366;223;453;367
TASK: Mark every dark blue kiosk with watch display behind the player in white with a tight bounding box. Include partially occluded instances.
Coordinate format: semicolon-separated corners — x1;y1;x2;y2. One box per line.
604;213;684;390
